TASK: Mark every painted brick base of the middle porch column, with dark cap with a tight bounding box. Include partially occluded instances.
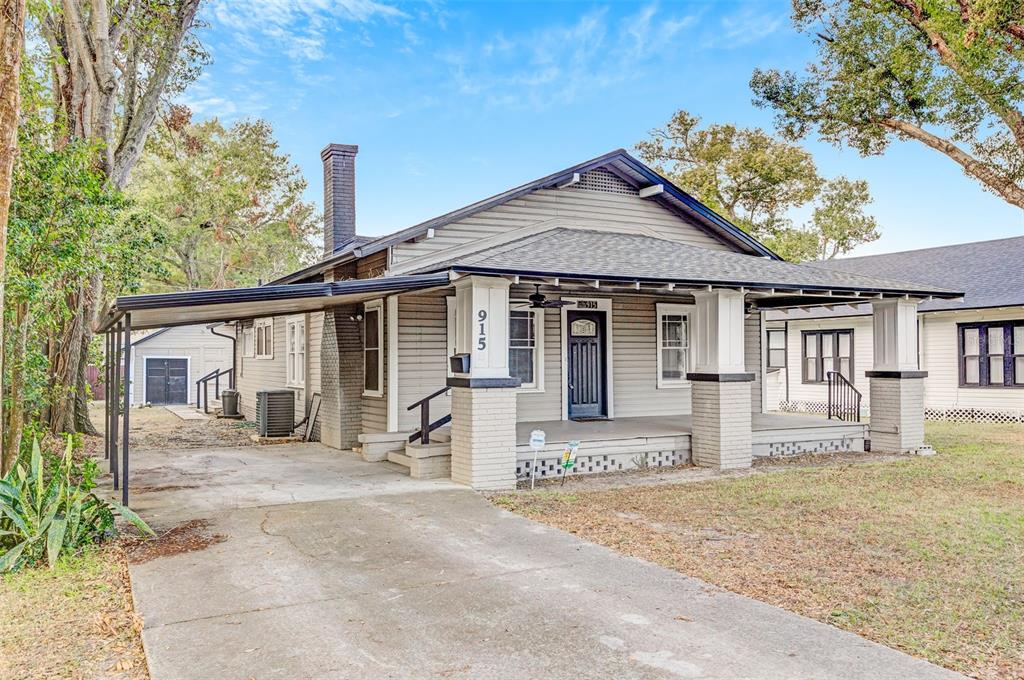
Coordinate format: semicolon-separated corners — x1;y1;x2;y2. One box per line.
690;374;754;470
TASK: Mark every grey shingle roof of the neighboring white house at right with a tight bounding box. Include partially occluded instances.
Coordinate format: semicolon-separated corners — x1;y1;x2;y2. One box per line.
774;237;1024;318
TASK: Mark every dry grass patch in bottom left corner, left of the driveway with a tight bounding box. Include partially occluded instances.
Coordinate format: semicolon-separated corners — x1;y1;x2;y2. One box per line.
0;547;150;680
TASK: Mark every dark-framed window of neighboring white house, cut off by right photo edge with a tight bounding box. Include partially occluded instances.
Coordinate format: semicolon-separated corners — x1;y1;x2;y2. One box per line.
958;321;1024;387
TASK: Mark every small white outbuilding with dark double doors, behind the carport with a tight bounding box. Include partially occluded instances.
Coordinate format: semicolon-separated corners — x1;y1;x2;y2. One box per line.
131;325;232;406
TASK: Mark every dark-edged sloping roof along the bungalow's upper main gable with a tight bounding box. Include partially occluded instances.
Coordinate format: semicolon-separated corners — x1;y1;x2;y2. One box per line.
270;148;781;284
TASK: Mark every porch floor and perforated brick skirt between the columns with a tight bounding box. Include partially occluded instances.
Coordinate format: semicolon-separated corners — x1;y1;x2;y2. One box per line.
516;413;867;479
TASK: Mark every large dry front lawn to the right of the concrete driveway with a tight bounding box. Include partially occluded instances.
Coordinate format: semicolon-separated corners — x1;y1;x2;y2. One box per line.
495;423;1024;679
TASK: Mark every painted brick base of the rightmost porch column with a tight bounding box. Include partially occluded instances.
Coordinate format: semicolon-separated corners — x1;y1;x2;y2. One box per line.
868;372;926;454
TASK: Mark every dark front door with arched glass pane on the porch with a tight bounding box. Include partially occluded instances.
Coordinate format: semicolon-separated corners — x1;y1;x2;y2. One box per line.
565;311;607;418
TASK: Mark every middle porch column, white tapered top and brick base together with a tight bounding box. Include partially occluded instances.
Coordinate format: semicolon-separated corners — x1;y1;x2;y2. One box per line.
687;290;754;470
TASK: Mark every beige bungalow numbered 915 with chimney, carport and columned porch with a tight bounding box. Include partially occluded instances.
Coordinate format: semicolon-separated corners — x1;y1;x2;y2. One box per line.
102;144;961;488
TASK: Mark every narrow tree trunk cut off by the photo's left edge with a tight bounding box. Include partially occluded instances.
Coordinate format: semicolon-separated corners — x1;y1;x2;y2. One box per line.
0;0;25;472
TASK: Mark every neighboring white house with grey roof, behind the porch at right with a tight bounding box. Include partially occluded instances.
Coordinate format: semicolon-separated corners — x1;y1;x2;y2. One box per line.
764;237;1024;422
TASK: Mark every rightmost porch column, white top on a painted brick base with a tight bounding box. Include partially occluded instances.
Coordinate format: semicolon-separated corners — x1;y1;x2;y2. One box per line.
867;298;928;453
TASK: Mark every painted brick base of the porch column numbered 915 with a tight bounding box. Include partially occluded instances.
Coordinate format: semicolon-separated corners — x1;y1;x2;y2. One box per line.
452;386;516;490
